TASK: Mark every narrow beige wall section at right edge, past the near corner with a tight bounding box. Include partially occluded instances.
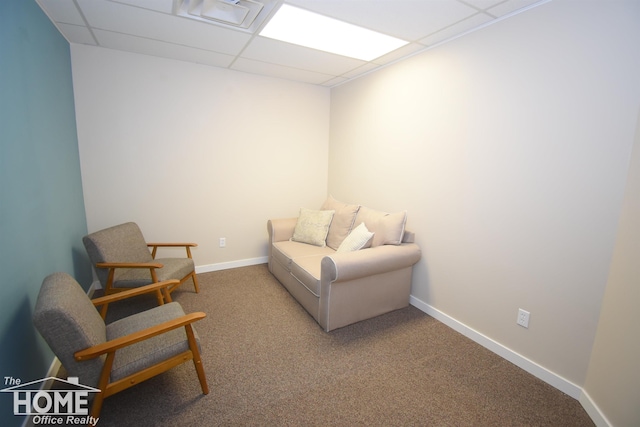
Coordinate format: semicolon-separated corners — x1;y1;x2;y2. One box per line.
581;108;640;426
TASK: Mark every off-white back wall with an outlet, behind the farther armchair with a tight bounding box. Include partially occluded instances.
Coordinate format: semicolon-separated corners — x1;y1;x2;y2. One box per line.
71;45;329;270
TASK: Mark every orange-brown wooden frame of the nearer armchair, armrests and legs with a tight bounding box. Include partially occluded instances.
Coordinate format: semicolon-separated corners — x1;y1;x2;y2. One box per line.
74;280;209;418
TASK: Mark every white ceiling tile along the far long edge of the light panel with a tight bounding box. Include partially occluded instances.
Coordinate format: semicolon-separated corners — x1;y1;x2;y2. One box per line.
241;37;365;76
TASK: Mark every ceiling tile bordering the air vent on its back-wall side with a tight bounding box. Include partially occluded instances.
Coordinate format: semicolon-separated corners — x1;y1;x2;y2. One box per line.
78;0;251;55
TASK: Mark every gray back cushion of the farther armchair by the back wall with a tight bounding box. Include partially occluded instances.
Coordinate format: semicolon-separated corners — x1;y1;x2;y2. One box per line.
82;222;153;287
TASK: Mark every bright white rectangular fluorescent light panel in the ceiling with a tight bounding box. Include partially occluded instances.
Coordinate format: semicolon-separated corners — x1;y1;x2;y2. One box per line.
260;4;408;61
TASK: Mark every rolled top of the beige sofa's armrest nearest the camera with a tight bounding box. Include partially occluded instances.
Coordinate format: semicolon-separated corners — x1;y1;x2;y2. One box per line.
321;243;422;282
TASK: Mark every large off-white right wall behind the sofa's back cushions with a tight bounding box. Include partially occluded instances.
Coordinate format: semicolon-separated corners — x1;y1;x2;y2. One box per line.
329;0;640;390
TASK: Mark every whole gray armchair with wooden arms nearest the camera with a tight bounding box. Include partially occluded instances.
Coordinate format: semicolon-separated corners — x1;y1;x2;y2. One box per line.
33;273;209;418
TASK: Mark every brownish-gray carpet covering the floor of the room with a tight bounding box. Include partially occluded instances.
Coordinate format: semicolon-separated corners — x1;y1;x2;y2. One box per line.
57;265;593;427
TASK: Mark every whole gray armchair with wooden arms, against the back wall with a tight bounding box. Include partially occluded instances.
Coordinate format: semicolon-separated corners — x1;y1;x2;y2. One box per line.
82;222;199;318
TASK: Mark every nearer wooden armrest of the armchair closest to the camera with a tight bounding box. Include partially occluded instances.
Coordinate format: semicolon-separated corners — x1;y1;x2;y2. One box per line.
74;311;207;362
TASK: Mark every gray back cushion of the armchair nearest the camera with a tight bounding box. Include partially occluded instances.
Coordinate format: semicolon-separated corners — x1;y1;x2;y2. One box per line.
33;273;107;387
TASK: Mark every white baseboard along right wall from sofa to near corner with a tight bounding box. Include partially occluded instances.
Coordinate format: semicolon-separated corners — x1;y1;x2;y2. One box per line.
409;295;583;400
